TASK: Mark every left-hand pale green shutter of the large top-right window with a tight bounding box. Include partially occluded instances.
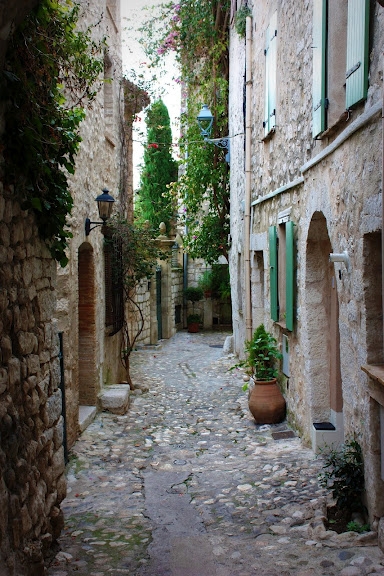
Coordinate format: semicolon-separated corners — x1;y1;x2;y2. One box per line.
312;0;327;138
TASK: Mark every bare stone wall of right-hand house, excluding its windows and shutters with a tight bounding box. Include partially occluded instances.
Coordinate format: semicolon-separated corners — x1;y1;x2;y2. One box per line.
229;0;384;519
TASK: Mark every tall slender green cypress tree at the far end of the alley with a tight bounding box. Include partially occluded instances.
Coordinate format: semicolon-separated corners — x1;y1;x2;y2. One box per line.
138;100;177;232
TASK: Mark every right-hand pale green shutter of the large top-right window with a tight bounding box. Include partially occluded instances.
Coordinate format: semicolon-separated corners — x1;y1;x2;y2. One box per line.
345;0;369;109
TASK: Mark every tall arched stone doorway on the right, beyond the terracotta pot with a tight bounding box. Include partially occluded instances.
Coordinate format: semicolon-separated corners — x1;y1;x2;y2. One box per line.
305;212;344;450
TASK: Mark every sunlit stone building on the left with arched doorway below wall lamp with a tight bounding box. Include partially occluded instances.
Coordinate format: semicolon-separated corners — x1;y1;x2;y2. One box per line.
56;0;149;447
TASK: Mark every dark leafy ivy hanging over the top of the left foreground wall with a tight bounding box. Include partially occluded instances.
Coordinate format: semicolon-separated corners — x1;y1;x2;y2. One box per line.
0;0;106;266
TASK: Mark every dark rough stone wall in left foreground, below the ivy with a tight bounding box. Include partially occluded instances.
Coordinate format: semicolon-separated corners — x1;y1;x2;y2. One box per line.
0;187;66;576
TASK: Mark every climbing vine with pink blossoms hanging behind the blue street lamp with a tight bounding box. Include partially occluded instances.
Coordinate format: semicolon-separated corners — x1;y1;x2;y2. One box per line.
141;0;230;263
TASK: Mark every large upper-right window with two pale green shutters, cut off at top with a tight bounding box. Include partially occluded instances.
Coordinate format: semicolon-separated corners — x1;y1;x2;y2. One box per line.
312;0;370;138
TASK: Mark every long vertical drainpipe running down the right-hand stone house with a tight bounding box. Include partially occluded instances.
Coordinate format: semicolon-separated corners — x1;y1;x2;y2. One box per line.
244;16;252;340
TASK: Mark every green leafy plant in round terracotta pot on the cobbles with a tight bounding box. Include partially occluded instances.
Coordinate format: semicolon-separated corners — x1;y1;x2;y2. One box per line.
235;324;286;424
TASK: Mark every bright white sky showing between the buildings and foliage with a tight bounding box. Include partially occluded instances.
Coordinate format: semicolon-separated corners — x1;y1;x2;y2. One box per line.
121;0;181;189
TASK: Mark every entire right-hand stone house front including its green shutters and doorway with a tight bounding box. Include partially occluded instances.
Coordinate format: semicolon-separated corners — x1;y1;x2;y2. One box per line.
229;0;384;540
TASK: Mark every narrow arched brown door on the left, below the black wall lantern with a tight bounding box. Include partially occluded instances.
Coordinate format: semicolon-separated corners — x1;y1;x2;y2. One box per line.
78;242;98;406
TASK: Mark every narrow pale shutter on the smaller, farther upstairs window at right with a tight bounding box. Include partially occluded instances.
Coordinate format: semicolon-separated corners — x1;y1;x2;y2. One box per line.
263;12;277;136
